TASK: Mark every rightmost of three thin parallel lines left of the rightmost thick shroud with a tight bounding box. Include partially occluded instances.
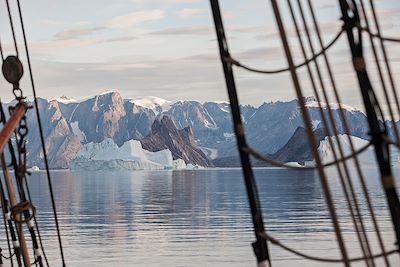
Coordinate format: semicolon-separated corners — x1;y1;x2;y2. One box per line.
307;0;390;266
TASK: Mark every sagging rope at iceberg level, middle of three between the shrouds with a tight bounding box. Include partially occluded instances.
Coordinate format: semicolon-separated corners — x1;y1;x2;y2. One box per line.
243;142;372;170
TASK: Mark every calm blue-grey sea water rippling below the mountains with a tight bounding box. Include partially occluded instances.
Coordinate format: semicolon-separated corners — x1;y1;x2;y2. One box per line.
2;167;400;267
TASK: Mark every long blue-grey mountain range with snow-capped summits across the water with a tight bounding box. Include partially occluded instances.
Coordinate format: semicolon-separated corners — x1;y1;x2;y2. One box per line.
3;91;390;168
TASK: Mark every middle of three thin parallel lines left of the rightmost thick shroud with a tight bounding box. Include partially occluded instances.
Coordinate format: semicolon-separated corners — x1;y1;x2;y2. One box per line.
297;0;375;266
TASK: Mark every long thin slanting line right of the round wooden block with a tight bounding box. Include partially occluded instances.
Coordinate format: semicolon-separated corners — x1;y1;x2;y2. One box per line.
17;0;66;267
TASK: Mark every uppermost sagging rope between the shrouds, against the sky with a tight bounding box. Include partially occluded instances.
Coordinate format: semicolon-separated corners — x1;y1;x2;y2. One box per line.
225;27;344;74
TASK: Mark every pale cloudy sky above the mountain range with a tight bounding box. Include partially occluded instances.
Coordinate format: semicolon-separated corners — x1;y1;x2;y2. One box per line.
0;0;400;110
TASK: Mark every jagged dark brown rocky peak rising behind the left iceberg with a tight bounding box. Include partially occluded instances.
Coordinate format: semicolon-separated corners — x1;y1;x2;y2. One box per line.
140;116;213;167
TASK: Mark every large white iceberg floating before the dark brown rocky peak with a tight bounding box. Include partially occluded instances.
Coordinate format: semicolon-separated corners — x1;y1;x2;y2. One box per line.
70;138;186;171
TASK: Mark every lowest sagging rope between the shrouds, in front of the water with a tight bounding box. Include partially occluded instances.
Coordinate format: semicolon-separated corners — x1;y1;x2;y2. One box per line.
259;232;399;263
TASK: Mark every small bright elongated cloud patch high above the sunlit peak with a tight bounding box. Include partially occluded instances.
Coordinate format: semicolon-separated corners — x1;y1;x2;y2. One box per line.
107;9;164;28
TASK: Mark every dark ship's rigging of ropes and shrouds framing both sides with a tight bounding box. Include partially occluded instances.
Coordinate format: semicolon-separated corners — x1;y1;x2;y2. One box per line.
0;0;400;267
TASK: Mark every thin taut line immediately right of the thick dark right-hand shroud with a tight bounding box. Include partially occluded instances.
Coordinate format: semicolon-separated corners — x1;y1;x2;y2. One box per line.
359;0;400;143
